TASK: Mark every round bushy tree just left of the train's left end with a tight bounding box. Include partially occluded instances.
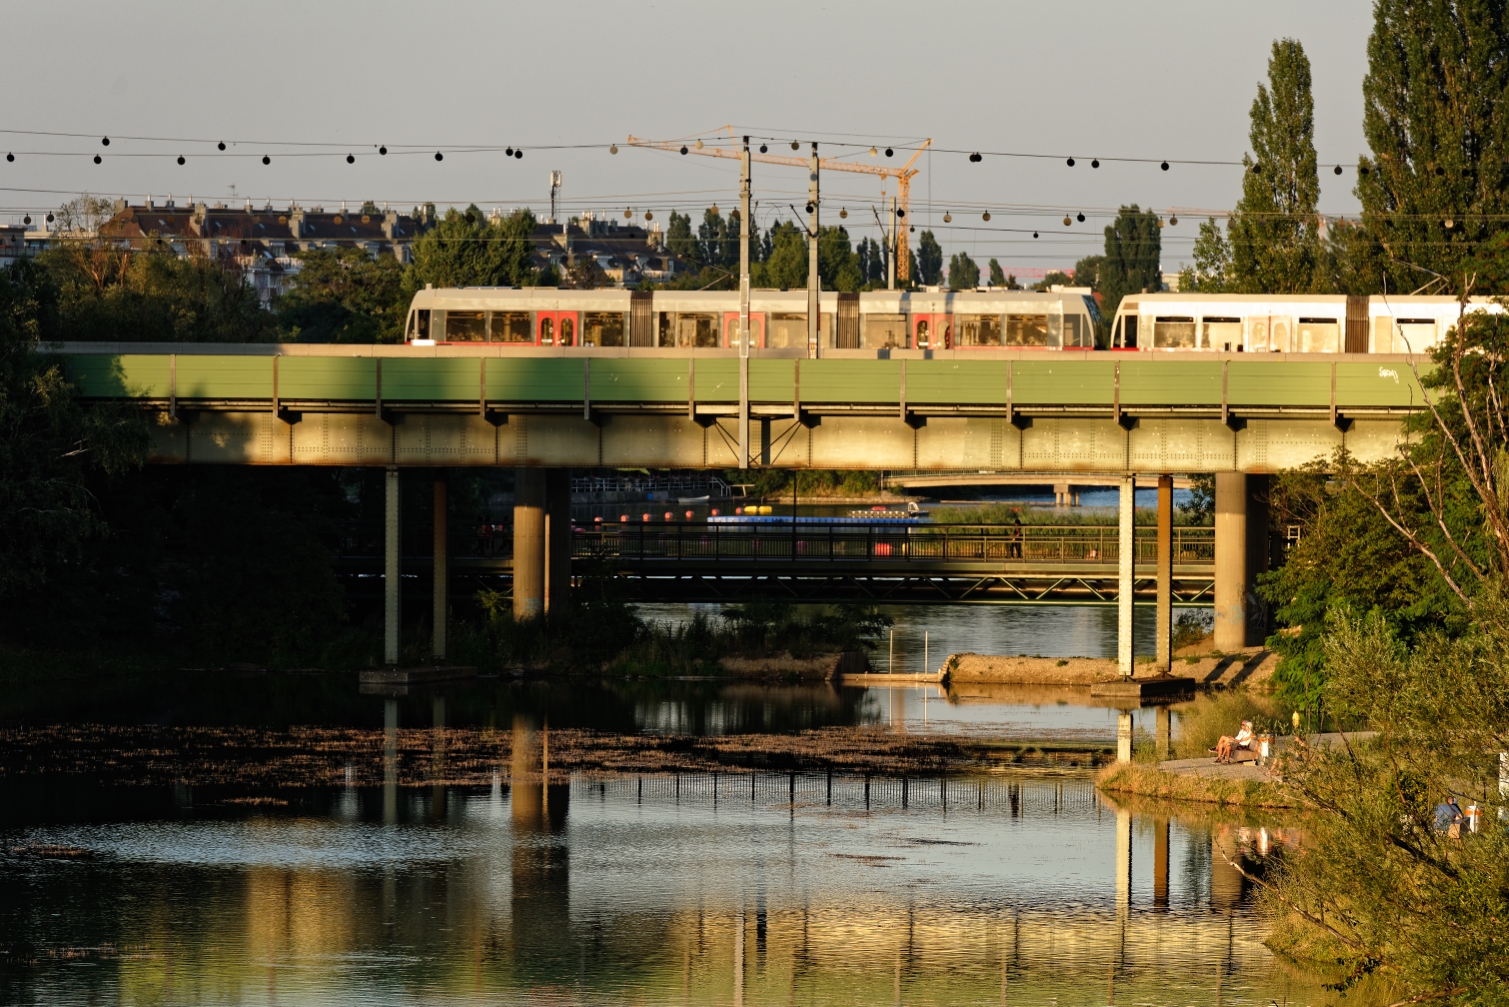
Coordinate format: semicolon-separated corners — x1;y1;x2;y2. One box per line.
278;248;409;343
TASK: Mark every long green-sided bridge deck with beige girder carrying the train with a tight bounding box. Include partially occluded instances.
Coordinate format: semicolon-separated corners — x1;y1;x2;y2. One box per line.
53;343;1428;473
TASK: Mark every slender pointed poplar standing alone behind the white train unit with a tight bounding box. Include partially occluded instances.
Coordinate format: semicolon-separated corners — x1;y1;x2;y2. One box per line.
1230;38;1320;294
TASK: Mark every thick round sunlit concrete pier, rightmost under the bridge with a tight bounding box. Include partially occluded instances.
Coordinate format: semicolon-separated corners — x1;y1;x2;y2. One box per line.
1215;473;1269;651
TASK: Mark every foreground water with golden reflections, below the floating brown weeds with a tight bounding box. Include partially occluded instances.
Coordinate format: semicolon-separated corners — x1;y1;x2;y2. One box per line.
0;779;1335;1004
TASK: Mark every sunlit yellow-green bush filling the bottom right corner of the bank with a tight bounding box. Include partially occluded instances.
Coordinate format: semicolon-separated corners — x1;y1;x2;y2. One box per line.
1265;603;1509;1004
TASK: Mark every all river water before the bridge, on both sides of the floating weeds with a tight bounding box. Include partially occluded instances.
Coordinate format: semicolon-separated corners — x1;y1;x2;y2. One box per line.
0;664;1364;1005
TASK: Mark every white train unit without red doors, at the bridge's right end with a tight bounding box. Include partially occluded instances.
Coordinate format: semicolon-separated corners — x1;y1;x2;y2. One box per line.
1111;293;1503;353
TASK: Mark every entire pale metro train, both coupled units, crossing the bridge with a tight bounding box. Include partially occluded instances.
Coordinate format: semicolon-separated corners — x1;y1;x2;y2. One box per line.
406;287;1484;356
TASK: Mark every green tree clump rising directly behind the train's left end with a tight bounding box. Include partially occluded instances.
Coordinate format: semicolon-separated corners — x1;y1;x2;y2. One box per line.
401;205;540;292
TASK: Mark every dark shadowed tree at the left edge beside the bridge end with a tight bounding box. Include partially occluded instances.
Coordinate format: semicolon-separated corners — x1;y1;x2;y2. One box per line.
0;260;146;601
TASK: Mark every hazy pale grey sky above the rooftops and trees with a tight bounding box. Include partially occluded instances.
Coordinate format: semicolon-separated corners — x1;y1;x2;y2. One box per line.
0;0;1372;278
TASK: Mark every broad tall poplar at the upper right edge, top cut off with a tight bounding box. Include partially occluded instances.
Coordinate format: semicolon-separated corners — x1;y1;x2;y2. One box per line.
1357;0;1509;291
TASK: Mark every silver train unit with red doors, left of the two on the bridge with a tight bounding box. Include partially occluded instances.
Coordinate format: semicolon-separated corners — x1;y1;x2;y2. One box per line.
406;287;1097;356
